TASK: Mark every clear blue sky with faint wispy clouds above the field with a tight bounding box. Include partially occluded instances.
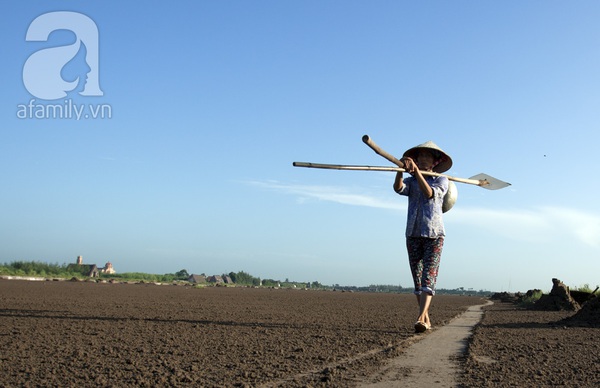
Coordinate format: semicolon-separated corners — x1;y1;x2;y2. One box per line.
0;1;600;291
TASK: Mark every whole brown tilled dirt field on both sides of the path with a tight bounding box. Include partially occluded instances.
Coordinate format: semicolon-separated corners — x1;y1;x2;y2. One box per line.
0;280;600;387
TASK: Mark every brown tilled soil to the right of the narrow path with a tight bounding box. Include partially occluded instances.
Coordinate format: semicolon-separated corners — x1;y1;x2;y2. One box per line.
459;301;600;388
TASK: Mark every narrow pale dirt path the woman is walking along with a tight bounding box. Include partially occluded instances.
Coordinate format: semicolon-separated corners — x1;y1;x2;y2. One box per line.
361;301;493;388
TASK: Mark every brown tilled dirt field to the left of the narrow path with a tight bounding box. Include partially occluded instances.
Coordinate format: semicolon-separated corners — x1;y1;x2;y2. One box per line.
0;280;482;387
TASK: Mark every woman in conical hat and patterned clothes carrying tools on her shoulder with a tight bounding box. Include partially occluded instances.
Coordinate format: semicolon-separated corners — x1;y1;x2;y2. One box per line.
394;141;452;333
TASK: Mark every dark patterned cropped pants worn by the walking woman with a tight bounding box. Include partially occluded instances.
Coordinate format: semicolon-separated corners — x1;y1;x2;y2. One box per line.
406;237;444;295
